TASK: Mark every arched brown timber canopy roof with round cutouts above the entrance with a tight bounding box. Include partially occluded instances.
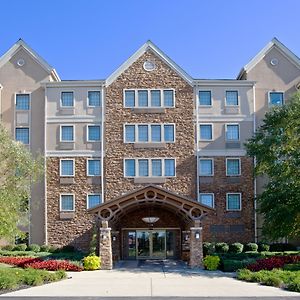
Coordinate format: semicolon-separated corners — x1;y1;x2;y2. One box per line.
88;185;214;223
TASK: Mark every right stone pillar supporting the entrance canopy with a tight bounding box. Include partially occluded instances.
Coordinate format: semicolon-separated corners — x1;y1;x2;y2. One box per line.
190;220;203;268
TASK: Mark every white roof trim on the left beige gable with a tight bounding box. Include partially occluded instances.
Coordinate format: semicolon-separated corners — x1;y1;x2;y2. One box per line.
0;39;60;81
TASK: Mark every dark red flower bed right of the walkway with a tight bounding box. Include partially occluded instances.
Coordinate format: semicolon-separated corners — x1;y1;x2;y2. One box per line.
247;255;300;272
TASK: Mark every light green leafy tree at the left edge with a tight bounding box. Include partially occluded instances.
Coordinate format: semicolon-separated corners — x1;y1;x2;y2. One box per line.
0;124;43;240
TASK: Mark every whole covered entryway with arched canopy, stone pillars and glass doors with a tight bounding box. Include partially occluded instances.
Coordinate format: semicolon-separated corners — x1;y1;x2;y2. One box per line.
90;185;213;268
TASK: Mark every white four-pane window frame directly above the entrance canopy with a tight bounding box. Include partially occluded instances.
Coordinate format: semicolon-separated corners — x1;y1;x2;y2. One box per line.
123;157;177;178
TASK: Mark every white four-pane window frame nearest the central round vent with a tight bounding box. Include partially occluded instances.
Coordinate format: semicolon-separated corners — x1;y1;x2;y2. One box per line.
123;88;176;109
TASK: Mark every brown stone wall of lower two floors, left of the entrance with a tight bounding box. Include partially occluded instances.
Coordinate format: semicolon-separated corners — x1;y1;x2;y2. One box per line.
47;157;101;250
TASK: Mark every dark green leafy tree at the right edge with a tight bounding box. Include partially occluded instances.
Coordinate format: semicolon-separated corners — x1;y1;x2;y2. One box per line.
246;93;300;240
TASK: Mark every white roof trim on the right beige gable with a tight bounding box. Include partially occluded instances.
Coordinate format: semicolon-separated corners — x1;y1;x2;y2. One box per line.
237;37;300;79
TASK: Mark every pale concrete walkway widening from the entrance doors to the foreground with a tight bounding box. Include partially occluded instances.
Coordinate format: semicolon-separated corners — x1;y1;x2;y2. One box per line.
0;261;300;299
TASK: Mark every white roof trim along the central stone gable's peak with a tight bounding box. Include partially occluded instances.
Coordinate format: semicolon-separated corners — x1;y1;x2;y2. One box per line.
106;40;193;86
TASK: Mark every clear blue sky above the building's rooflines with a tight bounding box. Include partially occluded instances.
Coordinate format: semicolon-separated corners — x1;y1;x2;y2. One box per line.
0;0;300;79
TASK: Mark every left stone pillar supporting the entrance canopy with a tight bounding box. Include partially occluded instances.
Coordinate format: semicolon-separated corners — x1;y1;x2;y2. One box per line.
99;221;113;270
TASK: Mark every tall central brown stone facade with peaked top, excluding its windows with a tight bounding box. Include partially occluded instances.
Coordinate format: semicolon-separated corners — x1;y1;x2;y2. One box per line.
104;50;196;201
